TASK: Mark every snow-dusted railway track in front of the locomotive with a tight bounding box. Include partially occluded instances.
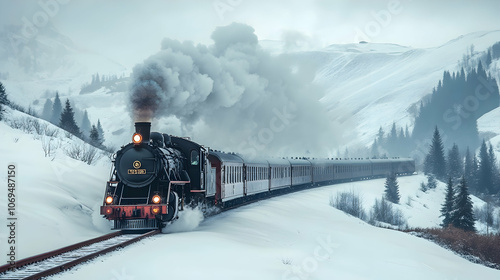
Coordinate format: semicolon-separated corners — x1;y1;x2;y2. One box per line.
0;230;160;280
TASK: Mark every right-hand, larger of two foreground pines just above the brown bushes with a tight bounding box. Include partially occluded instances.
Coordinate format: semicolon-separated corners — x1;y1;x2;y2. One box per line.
451;177;476;231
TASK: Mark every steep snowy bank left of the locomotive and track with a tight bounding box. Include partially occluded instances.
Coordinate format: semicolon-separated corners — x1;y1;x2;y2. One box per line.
0;110;110;258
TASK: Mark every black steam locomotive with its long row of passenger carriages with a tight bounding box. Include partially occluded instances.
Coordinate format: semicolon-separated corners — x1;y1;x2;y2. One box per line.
101;122;415;230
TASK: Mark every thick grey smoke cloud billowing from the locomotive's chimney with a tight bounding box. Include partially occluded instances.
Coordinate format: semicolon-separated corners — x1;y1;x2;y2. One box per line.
130;23;339;157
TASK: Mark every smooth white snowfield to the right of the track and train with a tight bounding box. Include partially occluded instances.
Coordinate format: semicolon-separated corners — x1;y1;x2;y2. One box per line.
47;176;500;280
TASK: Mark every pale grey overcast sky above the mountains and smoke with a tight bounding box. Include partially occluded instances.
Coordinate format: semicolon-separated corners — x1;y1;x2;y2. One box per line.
0;0;500;66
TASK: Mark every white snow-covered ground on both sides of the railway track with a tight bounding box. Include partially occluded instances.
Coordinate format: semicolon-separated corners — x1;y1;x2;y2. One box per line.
0;111;500;280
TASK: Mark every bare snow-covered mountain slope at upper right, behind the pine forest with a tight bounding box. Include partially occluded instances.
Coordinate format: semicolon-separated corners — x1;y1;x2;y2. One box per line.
315;31;500;145
